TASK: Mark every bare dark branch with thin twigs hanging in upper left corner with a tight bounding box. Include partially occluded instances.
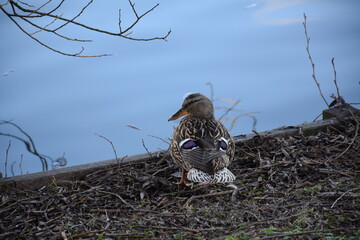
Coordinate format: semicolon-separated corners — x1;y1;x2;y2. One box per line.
0;0;171;57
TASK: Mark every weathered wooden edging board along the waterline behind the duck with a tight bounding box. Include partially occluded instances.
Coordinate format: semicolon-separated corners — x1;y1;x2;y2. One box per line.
0;106;359;191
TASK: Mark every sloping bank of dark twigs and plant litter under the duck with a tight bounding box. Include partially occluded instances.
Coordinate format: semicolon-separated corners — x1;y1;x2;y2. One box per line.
0;121;360;240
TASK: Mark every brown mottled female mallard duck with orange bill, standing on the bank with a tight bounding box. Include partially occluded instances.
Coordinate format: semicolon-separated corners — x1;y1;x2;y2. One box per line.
169;93;235;185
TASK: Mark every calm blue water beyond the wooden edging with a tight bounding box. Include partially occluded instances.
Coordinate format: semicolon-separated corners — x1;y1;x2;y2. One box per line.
0;0;360;176
